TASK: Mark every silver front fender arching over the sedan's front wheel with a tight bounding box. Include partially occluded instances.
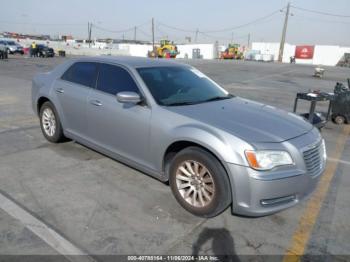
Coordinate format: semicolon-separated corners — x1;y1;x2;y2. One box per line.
150;107;251;177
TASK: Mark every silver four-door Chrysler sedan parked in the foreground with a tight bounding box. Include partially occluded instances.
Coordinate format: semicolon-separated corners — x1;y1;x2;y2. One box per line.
32;57;326;217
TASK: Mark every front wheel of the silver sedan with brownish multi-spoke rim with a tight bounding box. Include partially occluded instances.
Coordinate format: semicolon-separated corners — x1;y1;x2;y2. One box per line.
169;147;232;217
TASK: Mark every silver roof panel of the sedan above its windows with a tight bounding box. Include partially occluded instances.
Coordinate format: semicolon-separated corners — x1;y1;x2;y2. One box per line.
75;56;188;68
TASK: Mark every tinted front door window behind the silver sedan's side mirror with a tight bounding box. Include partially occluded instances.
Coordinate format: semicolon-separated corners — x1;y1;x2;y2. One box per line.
97;64;139;95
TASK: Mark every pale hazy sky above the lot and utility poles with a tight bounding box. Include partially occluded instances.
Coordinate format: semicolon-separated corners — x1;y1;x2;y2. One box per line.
0;0;350;46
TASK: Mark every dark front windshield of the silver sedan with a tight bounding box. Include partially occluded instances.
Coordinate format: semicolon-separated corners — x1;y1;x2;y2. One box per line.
137;66;233;106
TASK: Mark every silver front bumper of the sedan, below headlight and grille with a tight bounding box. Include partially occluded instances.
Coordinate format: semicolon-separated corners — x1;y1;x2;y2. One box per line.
229;164;321;216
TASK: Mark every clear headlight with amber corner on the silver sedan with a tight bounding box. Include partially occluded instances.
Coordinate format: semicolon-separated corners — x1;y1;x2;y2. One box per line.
245;150;293;170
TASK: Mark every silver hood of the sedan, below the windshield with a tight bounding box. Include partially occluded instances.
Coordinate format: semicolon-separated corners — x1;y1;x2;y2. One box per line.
166;97;313;143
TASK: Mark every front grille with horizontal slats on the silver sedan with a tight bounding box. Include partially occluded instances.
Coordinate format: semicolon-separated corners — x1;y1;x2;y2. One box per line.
303;142;325;176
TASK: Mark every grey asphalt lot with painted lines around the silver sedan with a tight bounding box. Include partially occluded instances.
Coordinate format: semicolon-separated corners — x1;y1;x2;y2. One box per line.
0;57;350;261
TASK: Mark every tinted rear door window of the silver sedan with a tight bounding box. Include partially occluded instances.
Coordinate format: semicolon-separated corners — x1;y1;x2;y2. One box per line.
61;62;97;87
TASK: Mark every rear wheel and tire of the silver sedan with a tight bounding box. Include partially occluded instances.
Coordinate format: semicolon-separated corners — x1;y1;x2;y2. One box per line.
39;101;64;143
